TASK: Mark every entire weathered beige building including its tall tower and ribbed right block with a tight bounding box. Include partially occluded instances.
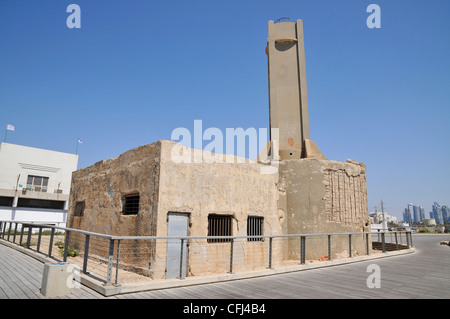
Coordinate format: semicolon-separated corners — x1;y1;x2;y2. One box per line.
68;20;370;278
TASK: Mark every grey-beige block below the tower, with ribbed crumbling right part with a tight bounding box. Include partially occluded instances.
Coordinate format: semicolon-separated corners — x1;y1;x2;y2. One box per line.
279;159;370;259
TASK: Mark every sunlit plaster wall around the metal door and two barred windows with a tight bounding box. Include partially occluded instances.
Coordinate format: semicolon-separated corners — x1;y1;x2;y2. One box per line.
153;141;284;275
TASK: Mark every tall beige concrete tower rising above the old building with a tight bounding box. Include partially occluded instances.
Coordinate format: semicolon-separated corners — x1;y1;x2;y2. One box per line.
266;20;326;160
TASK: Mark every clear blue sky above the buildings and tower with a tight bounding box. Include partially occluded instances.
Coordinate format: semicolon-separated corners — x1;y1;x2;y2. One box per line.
0;0;450;217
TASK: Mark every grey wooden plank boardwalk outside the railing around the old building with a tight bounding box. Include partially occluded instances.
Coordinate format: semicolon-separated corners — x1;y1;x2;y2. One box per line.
0;235;450;299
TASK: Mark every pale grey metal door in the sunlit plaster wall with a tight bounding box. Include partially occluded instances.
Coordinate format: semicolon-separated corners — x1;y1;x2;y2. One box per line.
166;213;189;278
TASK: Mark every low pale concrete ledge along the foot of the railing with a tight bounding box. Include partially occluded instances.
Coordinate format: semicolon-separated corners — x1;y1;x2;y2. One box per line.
0;240;416;296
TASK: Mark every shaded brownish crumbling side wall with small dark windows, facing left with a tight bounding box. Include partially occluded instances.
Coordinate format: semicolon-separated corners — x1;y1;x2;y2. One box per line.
68;142;160;268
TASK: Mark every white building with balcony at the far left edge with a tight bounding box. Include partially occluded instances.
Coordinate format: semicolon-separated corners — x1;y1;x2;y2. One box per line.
0;143;78;227
